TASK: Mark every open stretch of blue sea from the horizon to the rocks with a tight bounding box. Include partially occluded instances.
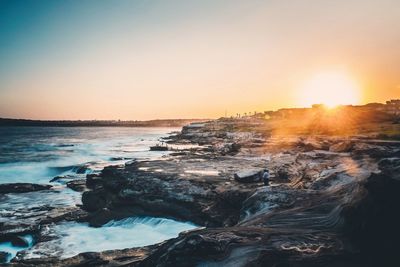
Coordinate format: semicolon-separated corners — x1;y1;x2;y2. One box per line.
0;127;173;183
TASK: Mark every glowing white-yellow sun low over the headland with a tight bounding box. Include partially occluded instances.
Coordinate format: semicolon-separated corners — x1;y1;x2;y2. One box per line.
299;72;360;108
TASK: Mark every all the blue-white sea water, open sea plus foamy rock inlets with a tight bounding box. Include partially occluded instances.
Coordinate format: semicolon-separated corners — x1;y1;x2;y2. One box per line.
0;127;195;262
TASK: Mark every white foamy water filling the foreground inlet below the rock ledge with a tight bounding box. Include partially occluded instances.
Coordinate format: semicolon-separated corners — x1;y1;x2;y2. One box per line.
26;217;197;258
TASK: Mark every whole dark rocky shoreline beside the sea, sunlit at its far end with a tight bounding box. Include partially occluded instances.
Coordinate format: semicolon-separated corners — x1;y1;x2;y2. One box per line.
0;120;400;266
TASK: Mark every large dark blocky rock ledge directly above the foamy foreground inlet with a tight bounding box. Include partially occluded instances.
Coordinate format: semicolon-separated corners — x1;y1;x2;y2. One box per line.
82;156;255;226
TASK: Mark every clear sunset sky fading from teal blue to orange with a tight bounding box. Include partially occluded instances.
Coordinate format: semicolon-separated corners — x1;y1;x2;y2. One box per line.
0;0;400;120
